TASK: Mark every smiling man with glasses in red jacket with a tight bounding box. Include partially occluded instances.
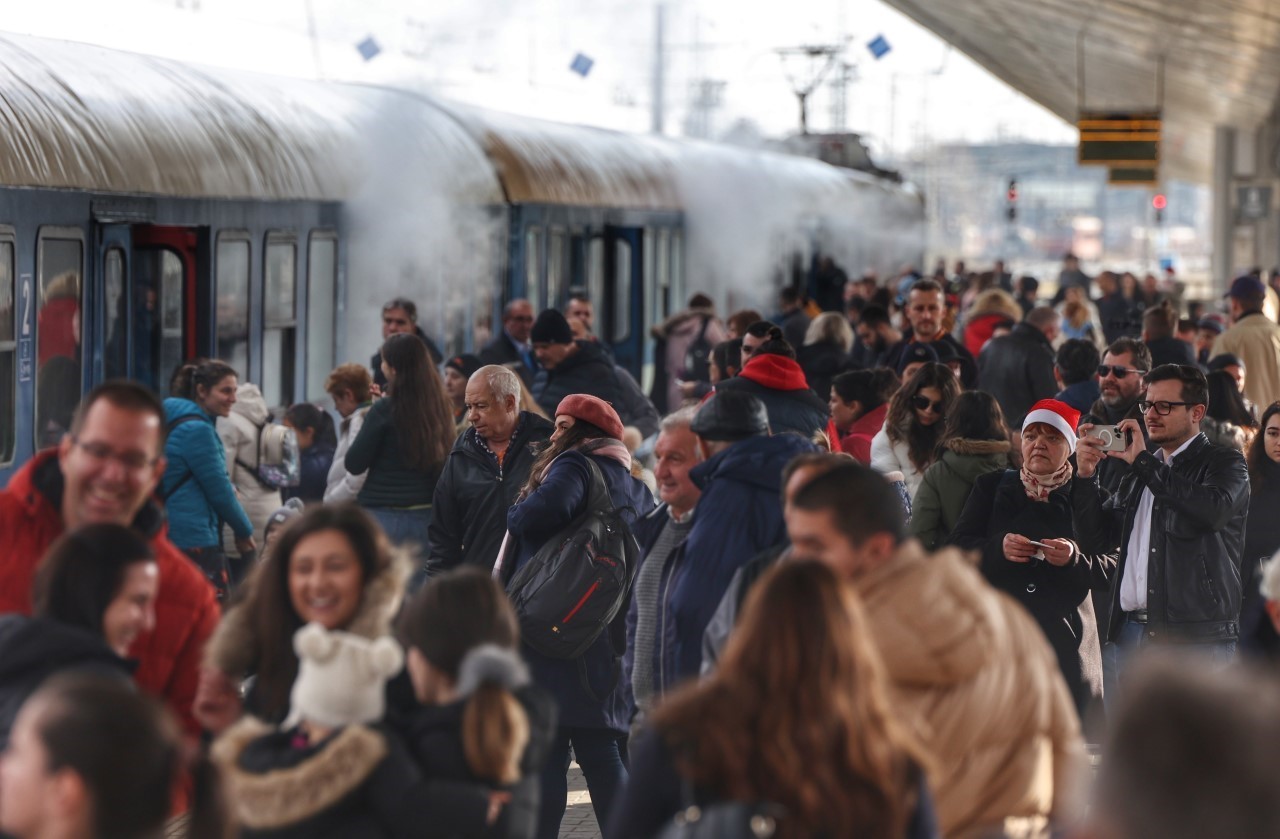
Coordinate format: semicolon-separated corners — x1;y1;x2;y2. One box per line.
0;380;219;734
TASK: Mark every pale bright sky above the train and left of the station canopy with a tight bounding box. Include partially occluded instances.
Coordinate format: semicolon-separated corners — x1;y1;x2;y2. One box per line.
0;0;1075;159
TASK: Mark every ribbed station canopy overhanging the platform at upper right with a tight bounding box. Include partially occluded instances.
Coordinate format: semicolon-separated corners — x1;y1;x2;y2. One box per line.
886;0;1280;183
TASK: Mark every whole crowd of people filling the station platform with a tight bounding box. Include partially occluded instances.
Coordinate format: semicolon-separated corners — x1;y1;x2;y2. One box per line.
0;256;1280;839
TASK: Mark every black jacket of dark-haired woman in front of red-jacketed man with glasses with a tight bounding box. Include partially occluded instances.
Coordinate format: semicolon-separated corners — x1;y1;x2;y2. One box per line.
0;615;133;751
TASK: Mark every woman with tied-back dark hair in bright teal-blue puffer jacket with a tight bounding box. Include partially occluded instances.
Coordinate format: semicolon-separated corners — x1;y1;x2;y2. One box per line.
160;359;257;599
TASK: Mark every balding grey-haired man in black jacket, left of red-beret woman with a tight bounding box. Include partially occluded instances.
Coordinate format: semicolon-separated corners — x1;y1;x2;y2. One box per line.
426;364;553;575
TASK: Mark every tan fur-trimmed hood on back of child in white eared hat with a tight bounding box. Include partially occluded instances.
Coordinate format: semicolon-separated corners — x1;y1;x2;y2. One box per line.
210;717;389;830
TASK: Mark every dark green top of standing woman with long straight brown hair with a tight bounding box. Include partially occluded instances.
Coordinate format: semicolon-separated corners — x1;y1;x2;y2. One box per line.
344;396;440;507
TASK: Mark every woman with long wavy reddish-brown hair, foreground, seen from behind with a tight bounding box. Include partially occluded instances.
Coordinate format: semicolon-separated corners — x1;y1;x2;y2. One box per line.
608;561;937;839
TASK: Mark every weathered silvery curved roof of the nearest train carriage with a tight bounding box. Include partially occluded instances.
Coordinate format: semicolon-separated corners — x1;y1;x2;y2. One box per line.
0;33;502;202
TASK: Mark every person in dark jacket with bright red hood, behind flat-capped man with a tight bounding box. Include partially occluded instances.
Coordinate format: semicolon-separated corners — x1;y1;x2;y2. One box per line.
716;339;831;438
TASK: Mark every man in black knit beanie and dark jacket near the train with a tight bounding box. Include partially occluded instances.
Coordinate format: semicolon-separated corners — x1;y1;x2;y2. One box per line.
530;309;622;416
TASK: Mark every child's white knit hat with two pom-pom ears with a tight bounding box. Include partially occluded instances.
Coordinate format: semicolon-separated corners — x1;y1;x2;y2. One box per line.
284;623;404;728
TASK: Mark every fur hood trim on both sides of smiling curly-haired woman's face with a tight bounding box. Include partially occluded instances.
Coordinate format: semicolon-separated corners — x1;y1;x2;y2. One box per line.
205;548;412;679
